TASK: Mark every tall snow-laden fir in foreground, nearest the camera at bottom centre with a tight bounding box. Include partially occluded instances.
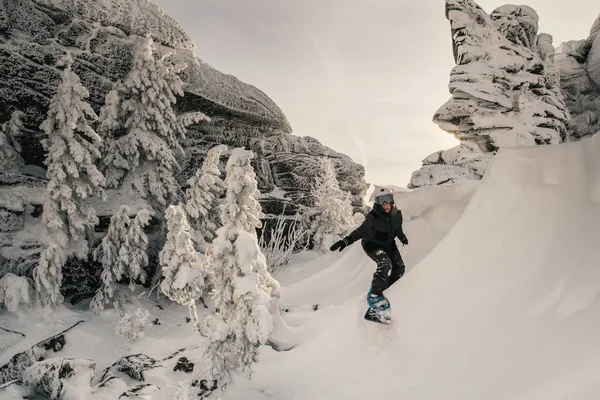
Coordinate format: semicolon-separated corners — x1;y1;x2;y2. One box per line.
199;149;273;387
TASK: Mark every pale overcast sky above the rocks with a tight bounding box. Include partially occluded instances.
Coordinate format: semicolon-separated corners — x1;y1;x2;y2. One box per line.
152;0;600;186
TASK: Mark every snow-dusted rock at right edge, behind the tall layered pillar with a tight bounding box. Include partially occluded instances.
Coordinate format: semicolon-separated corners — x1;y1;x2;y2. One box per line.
556;16;600;139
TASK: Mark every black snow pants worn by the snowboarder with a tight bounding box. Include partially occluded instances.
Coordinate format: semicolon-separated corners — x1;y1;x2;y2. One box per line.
361;240;405;296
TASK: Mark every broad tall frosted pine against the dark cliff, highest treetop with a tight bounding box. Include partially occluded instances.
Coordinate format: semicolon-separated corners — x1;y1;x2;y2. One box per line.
99;36;185;210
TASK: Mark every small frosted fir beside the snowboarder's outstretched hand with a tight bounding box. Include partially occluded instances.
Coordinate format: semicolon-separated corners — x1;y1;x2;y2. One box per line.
311;157;354;251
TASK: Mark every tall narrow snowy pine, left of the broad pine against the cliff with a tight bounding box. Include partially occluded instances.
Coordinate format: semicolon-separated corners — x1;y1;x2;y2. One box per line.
34;54;105;305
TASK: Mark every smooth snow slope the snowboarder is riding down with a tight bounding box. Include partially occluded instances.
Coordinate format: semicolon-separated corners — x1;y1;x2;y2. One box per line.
239;132;600;400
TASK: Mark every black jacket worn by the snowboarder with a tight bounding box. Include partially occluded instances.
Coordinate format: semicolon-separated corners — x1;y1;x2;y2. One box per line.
345;204;406;247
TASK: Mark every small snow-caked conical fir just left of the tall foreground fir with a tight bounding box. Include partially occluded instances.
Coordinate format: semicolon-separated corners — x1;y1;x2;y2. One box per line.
159;205;206;306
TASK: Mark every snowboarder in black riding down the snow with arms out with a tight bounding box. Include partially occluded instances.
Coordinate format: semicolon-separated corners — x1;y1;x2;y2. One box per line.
329;188;408;322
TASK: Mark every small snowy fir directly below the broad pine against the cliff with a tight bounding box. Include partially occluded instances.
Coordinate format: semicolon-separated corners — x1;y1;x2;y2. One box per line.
90;205;150;313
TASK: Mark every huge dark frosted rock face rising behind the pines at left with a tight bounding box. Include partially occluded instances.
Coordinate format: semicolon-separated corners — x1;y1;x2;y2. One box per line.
0;0;366;205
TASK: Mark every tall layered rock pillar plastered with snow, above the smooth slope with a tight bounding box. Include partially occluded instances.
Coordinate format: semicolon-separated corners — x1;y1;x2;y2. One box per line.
409;0;570;188
